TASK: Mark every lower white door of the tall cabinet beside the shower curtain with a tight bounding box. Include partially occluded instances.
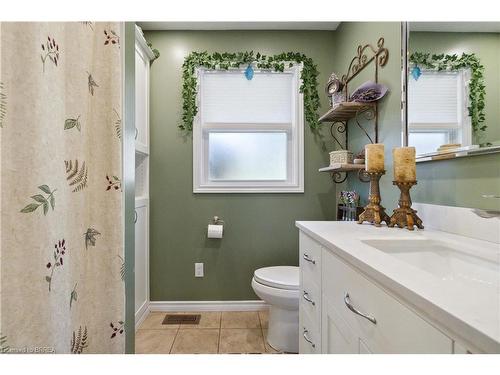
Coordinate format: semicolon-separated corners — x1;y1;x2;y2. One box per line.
135;200;149;317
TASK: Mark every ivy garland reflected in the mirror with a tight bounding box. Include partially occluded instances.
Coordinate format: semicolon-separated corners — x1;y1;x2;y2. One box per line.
410;52;486;132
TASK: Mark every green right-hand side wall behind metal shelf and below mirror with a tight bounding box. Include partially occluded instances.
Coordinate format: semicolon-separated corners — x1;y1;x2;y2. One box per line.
334;22;500;214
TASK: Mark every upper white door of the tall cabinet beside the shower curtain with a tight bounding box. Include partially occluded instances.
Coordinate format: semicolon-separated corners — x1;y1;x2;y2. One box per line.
135;42;149;154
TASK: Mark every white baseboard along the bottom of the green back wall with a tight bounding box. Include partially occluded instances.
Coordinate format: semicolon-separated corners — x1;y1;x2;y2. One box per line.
149;300;269;312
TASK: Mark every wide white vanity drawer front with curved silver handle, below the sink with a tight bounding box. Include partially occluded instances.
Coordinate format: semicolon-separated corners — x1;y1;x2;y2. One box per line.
322;250;452;353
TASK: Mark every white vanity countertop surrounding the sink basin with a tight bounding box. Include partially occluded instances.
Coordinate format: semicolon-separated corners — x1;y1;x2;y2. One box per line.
296;221;500;353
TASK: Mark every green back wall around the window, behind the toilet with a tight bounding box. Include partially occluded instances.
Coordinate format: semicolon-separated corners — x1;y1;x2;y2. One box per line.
145;31;335;301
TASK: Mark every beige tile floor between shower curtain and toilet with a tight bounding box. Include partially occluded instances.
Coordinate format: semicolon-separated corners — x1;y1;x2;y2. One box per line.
135;311;278;354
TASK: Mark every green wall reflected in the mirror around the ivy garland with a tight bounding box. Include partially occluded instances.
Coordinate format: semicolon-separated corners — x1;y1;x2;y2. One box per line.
409;31;500;144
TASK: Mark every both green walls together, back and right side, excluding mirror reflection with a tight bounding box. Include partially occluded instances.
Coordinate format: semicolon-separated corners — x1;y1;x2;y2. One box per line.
146;22;500;301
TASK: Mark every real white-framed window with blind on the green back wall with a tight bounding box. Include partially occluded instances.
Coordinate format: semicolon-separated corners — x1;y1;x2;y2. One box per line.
193;66;304;193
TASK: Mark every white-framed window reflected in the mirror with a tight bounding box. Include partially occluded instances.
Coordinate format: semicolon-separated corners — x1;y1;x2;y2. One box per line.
408;70;472;154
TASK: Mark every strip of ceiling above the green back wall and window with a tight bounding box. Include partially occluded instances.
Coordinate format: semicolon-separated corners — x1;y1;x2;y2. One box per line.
137;21;340;31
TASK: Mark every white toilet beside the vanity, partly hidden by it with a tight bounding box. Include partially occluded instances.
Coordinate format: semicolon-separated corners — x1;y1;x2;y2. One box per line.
252;266;299;353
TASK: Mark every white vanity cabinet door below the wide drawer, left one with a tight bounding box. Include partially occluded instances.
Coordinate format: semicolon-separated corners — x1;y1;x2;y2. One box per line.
321;294;362;354
